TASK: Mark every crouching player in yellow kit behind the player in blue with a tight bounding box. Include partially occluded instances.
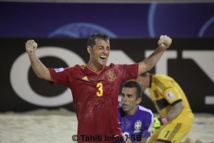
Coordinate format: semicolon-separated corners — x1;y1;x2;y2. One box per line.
137;73;194;143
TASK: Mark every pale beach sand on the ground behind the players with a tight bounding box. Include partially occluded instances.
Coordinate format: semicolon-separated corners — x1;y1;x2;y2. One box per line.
0;109;214;143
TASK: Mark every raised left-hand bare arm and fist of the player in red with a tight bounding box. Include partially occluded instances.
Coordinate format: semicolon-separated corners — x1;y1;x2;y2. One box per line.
25;40;52;81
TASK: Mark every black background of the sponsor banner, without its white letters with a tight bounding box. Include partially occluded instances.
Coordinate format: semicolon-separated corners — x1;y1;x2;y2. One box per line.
0;38;214;112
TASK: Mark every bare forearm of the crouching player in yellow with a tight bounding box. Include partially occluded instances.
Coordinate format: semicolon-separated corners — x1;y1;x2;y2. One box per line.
166;101;184;121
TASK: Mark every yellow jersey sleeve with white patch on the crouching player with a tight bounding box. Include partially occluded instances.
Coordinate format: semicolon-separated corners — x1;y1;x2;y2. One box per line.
163;87;182;105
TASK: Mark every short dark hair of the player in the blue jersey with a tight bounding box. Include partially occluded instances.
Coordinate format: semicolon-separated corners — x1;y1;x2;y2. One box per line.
122;80;143;98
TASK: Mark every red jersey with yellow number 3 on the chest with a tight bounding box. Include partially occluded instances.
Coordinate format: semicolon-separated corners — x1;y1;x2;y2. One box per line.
49;64;138;143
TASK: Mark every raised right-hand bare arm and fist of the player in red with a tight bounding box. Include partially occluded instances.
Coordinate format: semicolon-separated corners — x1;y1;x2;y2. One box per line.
138;35;172;75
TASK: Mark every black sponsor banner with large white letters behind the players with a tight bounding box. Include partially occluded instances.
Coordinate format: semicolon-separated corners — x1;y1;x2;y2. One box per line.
0;38;214;113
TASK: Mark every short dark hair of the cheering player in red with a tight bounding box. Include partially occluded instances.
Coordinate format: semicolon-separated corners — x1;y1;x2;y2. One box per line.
87;33;109;47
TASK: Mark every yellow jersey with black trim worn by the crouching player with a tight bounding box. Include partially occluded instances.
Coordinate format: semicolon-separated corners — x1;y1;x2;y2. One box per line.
148;74;194;122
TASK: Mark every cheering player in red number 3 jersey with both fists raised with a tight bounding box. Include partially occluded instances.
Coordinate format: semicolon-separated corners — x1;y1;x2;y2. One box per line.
25;33;172;143
